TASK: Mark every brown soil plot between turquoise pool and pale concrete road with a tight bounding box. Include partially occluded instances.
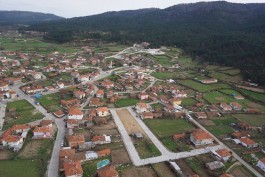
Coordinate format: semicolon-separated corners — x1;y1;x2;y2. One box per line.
111;148;131;165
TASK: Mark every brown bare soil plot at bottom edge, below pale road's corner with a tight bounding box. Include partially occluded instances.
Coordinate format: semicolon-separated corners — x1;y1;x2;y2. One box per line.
121;167;157;177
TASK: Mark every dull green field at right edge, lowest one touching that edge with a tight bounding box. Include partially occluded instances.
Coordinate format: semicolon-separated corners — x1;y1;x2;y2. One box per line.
234;114;265;127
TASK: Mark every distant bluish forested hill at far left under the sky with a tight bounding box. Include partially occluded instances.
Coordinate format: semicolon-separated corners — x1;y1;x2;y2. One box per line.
0;11;63;25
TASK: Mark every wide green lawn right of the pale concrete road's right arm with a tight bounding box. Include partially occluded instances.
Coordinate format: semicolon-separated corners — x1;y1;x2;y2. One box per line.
144;119;194;138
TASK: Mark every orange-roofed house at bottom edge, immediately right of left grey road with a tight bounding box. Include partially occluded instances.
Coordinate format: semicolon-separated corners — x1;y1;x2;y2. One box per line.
63;161;83;177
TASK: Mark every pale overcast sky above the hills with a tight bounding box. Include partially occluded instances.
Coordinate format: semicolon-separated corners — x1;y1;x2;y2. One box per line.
0;0;265;17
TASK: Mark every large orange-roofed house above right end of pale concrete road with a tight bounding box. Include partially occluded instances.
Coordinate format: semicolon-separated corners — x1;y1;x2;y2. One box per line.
190;129;214;146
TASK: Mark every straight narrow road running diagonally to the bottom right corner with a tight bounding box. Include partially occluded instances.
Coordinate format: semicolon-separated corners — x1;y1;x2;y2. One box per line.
189;115;263;177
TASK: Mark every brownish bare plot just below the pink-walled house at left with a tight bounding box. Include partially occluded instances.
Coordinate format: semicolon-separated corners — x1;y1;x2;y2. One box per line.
18;140;42;159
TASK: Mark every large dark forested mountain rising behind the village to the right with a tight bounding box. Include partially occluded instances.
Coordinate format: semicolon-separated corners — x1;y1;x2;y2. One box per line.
24;1;265;85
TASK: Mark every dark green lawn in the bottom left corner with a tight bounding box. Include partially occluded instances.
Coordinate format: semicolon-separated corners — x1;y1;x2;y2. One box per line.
0;160;40;177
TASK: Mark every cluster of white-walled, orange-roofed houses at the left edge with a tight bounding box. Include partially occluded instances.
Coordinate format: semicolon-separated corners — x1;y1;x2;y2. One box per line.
0;120;54;152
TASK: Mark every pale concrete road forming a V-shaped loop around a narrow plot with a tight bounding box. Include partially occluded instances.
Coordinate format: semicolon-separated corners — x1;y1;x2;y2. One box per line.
110;109;223;166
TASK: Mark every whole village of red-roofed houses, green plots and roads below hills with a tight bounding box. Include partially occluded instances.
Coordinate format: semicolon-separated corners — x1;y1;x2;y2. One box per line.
0;32;265;177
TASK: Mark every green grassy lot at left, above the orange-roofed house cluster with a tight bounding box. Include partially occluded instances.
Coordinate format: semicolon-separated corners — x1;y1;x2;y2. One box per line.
3;100;44;129
